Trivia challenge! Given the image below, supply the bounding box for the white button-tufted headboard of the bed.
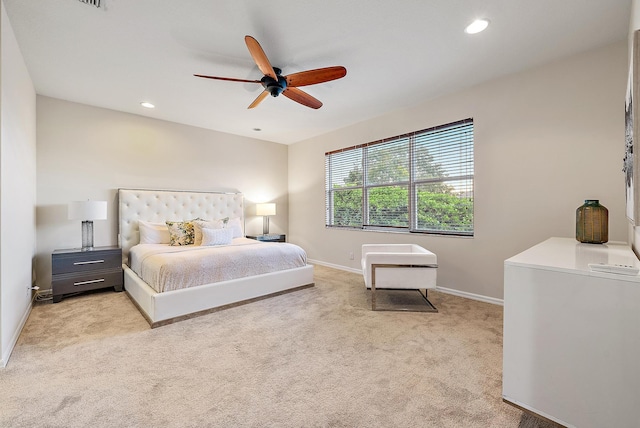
[118,189,244,262]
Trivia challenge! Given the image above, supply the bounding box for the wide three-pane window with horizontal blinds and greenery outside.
[325,119,474,236]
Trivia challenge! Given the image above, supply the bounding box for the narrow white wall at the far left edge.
[0,3,36,367]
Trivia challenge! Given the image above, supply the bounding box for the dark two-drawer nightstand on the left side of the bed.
[51,246,124,303]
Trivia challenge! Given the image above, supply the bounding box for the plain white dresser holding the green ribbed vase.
[502,238,640,428]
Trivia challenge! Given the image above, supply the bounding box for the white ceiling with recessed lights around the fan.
[2,0,631,144]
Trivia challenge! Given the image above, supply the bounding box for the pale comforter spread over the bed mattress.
[129,238,307,293]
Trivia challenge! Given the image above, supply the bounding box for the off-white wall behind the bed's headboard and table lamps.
[36,96,288,288]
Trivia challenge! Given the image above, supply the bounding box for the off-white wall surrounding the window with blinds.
[289,42,627,299]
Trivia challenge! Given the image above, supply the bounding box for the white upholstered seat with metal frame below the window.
[362,244,438,312]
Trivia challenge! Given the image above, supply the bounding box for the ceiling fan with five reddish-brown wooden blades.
[194,36,347,109]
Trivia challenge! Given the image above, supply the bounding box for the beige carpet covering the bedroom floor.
[0,266,549,428]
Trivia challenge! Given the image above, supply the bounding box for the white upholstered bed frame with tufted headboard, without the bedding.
[118,189,314,328]
